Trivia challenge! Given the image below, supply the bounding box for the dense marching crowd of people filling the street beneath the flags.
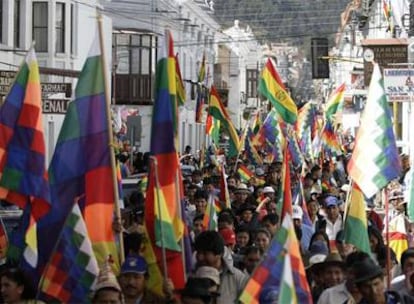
[0,146,414,304]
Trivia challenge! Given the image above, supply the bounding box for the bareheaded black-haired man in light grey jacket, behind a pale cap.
[194,231,248,304]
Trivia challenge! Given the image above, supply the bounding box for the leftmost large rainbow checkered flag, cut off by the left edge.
[0,48,51,267]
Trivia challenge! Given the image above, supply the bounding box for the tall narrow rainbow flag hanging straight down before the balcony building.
[145,30,186,289]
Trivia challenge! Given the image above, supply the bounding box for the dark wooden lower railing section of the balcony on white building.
[112,74,154,105]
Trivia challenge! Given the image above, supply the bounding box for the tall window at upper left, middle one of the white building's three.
[33,2,48,52]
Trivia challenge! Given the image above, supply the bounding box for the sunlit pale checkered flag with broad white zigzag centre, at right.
[348,64,401,198]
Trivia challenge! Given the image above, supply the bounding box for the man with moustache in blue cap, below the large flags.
[119,255,165,304]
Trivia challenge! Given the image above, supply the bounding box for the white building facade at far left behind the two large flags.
[0,0,112,164]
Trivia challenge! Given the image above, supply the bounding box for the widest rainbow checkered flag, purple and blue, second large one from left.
[32,25,119,290]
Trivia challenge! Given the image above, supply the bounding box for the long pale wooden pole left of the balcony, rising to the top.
[98,13,125,264]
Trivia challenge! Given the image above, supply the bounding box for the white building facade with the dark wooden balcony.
[105,0,219,152]
